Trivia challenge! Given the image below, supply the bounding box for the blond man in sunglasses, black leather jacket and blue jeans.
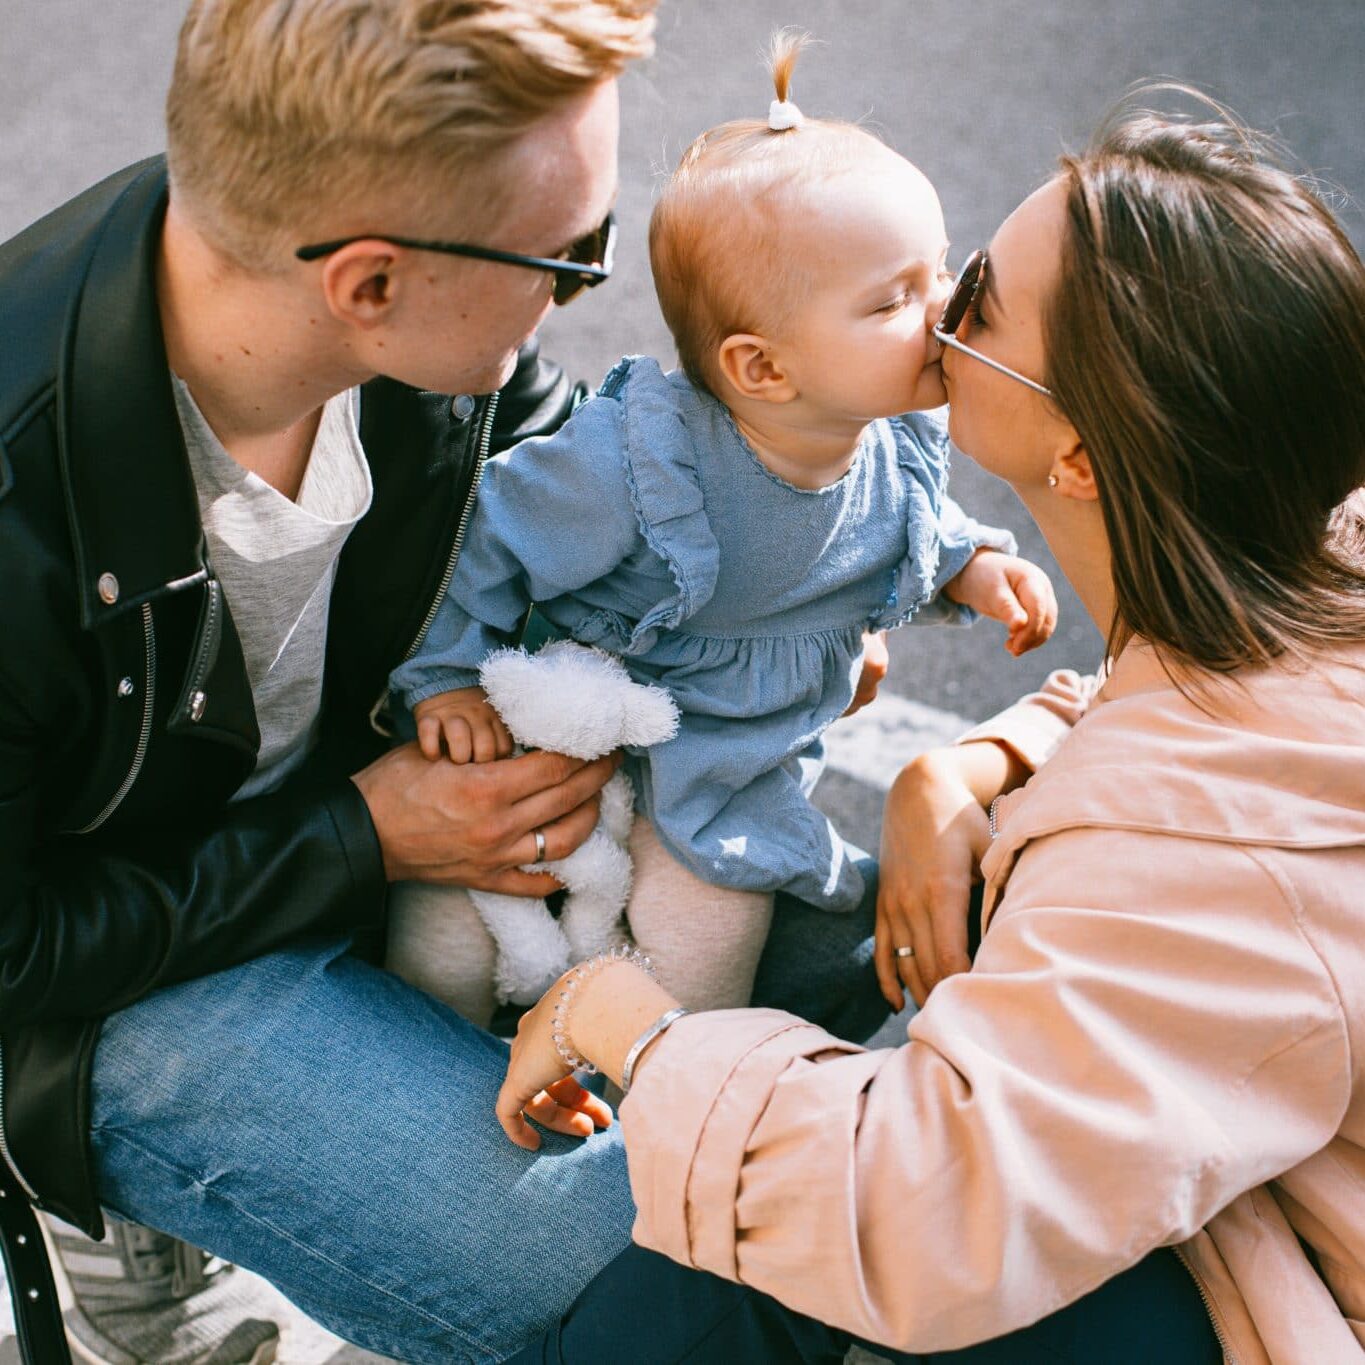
[0,0,652,1365]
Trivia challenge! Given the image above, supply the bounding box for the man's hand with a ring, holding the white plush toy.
[351,744,621,895]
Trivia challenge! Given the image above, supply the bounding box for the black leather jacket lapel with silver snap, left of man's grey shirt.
[57,157,259,753]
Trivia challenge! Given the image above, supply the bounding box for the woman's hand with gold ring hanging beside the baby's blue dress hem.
[874,745,1005,1010]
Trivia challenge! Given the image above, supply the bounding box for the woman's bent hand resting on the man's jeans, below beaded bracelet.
[497,973,612,1152]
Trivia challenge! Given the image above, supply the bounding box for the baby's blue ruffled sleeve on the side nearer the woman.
[871,410,1018,631]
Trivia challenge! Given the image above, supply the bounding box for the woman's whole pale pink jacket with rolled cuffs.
[621,644,1365,1365]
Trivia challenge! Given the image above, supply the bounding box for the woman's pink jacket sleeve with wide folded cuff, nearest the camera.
[621,829,1350,1351]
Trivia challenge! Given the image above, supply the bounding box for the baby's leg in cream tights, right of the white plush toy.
[625,816,773,1010]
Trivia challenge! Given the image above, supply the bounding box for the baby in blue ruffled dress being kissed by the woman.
[390,29,1055,1009]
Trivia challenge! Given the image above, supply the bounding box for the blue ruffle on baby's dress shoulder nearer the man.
[614,356,721,654]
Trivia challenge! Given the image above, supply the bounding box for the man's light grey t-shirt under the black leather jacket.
[171,375,374,800]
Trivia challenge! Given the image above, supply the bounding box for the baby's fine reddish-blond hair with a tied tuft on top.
[650,30,885,392]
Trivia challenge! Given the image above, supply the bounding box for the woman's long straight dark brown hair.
[1044,90,1365,673]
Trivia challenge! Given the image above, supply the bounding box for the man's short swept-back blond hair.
[167,0,657,270]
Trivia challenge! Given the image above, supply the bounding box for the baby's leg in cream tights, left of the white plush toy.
[384,882,498,1028]
